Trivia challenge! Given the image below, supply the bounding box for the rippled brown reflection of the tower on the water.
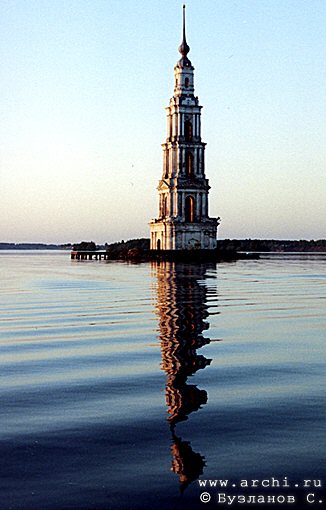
[155,262,215,491]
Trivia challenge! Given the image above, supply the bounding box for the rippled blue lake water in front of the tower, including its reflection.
[0,252,326,510]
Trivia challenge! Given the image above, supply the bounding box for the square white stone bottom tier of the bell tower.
[150,218,218,251]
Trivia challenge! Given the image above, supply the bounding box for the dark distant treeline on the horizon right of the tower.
[217,239,326,252]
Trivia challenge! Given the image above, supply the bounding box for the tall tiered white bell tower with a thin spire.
[150,6,219,250]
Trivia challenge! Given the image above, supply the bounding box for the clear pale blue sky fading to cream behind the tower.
[0,0,326,243]
